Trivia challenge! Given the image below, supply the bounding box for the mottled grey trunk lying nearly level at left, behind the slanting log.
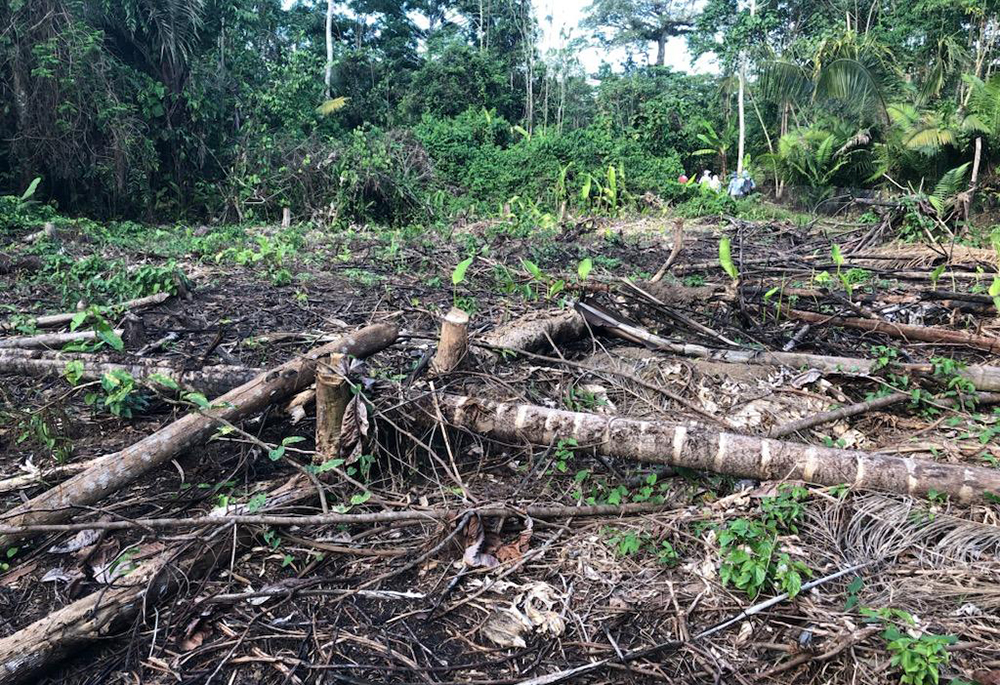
[0,349,262,396]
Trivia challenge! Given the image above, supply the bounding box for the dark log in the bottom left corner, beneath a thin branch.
[0,476,316,685]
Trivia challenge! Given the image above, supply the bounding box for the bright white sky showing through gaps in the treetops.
[283,0,718,75]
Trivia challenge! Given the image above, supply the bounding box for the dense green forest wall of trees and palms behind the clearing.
[0,0,1000,224]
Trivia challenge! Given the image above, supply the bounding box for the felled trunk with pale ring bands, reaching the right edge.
[429,395,1000,502]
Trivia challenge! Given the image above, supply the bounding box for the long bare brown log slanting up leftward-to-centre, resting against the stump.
[0,324,398,548]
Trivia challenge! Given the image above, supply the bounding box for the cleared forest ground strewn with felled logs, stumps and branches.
[0,211,1000,684]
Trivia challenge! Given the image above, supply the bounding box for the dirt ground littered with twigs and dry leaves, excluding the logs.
[0,218,1000,685]
